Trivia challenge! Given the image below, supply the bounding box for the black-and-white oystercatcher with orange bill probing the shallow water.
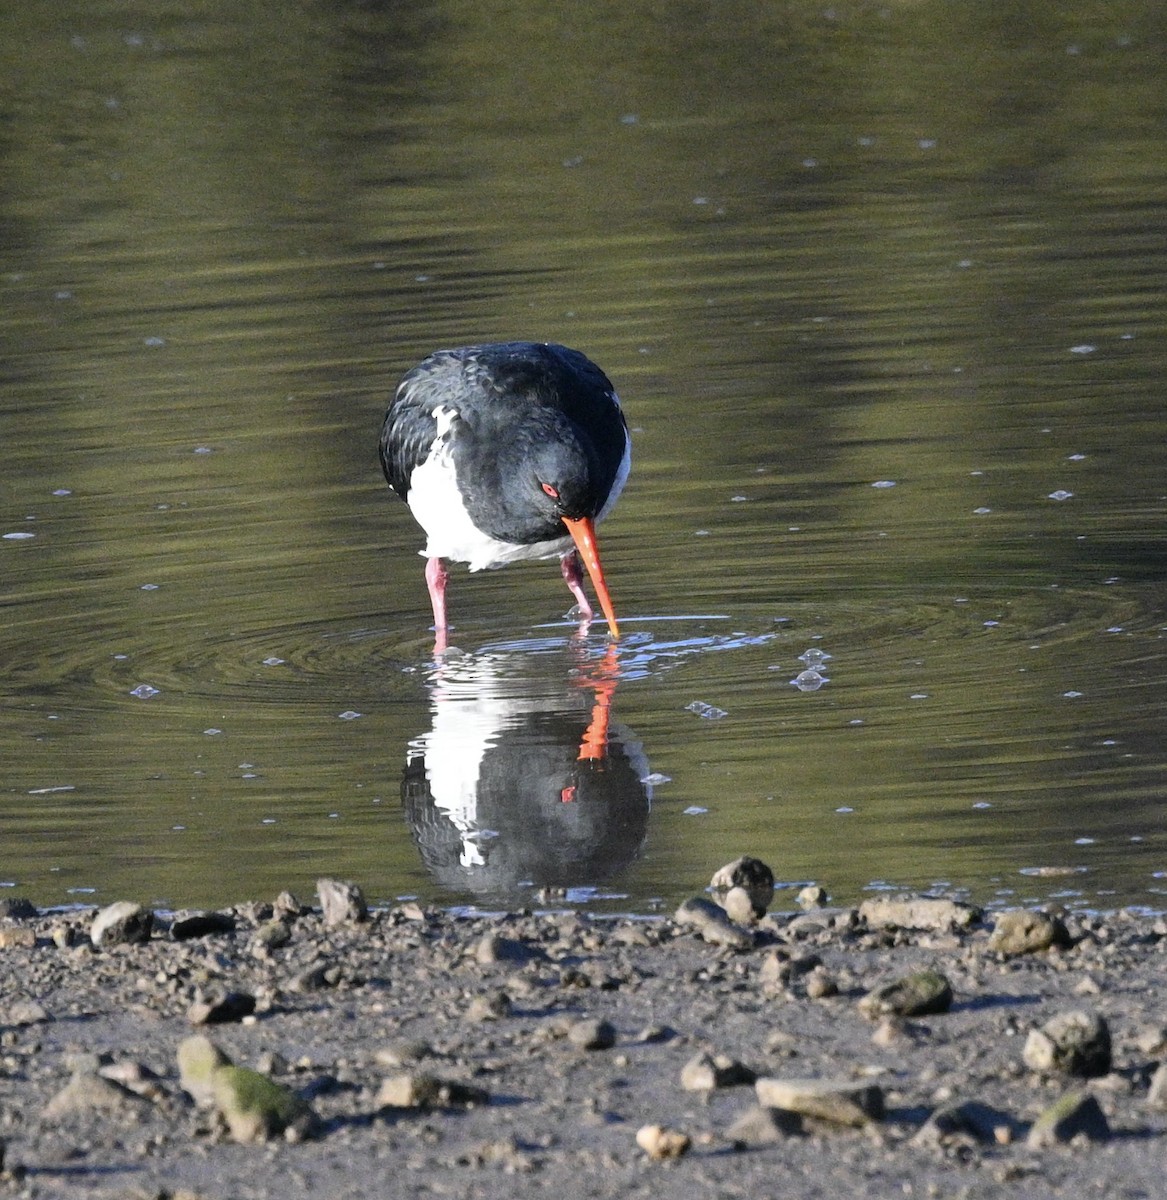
[381,342,632,649]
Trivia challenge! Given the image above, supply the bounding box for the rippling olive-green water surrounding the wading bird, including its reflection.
[0,0,1167,911]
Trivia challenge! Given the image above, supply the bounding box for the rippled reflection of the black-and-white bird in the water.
[401,640,652,901]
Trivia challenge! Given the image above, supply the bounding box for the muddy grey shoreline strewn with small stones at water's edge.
[0,886,1167,1200]
